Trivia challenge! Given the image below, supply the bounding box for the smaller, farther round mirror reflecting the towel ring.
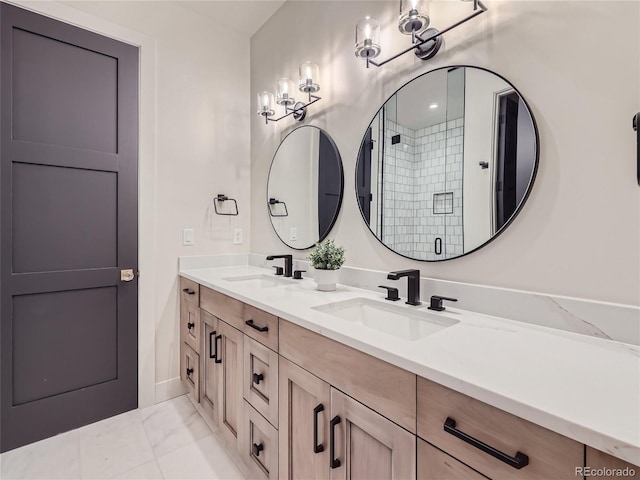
[267,125,344,250]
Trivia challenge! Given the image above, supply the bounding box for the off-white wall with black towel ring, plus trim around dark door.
[16,1,250,405]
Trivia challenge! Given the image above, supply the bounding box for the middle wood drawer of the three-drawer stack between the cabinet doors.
[242,335,278,427]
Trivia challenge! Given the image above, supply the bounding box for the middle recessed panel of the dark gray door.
[12,162,118,274]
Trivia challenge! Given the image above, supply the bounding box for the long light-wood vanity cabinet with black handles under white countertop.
[180,278,640,480]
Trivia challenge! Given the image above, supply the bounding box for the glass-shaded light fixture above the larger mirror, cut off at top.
[355,0,488,68]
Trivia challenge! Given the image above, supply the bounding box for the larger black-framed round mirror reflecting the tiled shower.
[356,66,538,261]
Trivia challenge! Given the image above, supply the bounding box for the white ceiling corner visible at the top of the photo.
[174,0,286,36]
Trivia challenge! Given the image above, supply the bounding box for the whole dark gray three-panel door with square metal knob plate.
[0,3,138,451]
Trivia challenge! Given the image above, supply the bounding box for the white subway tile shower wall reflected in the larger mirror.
[378,118,464,260]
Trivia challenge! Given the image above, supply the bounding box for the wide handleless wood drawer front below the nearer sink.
[280,319,416,433]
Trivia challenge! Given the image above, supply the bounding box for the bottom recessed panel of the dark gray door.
[12,287,118,406]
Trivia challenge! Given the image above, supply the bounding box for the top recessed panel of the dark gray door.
[12,28,118,153]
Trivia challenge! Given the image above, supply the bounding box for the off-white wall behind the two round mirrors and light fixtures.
[251,0,640,305]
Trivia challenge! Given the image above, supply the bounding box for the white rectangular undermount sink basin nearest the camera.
[313,298,458,341]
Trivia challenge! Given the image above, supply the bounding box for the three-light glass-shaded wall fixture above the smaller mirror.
[258,62,321,123]
